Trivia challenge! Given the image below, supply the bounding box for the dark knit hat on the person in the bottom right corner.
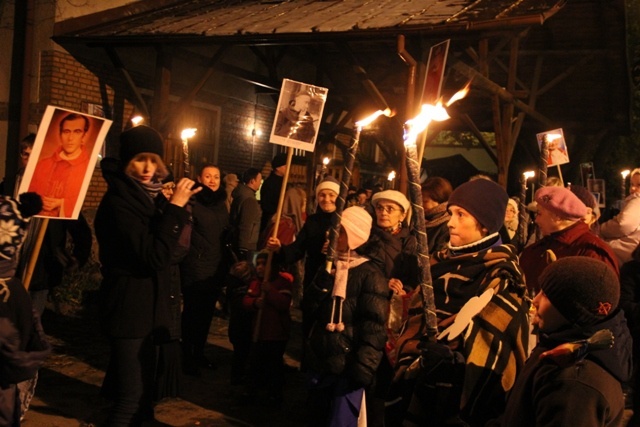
[540,256,620,326]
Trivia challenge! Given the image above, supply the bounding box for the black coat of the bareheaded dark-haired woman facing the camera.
[180,186,229,288]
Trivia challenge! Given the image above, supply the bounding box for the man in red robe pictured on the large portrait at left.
[29,113,90,217]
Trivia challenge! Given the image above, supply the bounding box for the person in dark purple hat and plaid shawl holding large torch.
[390,179,529,425]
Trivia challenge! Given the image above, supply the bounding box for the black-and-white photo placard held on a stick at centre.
[269,79,329,151]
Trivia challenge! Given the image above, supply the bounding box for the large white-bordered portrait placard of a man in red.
[18,105,112,219]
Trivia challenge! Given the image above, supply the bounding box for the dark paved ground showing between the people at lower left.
[23,310,305,427]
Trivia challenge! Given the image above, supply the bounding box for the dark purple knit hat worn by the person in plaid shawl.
[447,179,509,234]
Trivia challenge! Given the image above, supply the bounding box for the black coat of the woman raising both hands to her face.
[94,161,189,342]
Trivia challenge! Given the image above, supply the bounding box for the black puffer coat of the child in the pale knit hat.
[305,261,389,389]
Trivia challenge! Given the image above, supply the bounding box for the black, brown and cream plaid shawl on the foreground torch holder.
[395,245,530,420]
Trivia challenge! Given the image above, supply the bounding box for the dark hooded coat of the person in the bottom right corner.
[502,310,631,427]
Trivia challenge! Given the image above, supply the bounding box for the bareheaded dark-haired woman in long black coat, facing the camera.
[180,164,229,375]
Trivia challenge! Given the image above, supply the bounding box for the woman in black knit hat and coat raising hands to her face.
[95,126,200,426]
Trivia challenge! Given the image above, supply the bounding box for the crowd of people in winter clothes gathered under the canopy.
[0,126,640,426]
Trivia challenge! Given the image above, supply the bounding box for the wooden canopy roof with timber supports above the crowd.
[54,0,630,183]
